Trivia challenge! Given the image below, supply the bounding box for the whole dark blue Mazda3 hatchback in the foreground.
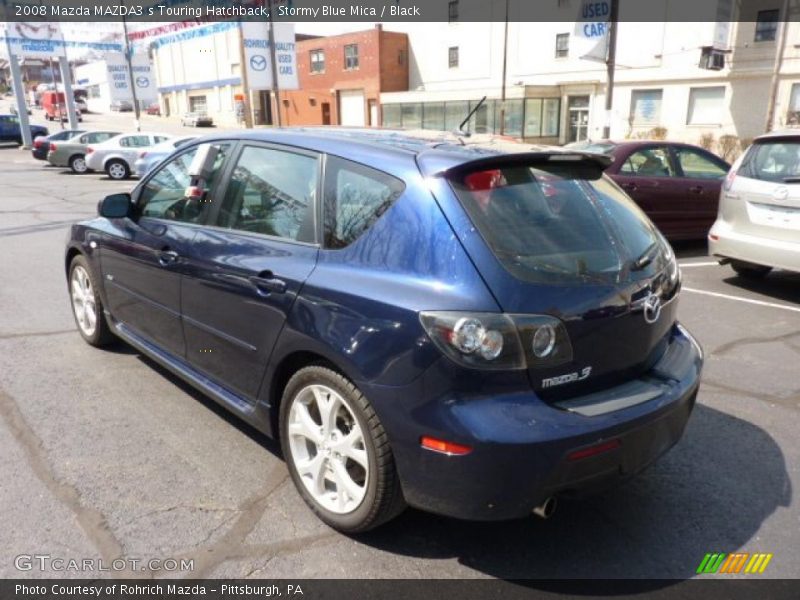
[65,129,703,532]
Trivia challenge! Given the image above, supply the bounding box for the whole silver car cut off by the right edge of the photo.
[708,130,800,278]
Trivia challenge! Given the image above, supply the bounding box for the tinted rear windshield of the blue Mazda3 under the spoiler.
[451,163,663,283]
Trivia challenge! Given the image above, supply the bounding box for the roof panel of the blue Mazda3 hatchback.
[189,126,612,174]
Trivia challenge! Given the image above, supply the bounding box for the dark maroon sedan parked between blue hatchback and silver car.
[567,140,730,240]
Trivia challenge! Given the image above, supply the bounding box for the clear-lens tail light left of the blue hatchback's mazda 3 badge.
[420,311,572,370]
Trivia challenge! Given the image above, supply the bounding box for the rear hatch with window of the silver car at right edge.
[725,136,800,242]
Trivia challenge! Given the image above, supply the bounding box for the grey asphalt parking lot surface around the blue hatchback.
[0,115,800,579]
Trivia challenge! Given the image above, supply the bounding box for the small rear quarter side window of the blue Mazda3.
[324,156,405,249]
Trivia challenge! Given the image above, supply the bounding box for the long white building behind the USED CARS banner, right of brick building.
[381,0,800,150]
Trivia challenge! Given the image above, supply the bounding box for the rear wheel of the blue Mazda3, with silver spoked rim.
[279,366,406,533]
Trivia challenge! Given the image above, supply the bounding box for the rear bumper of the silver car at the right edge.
[708,220,800,271]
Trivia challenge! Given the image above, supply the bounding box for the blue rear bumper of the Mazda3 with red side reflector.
[364,326,703,520]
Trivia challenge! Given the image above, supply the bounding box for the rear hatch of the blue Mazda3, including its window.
[422,153,679,401]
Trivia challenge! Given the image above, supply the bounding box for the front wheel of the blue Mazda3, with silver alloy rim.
[68,254,116,348]
